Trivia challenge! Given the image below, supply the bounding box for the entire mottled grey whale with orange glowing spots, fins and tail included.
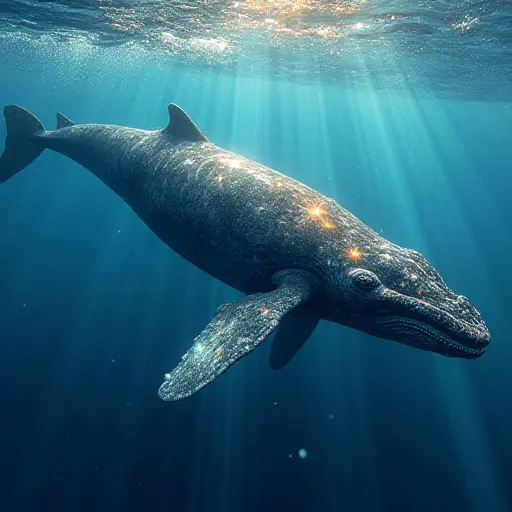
[0,105,490,401]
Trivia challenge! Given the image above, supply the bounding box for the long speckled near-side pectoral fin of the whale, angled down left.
[158,270,315,402]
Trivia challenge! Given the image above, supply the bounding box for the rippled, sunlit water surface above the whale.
[0,0,512,99]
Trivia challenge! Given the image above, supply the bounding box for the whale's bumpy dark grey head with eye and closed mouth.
[338,244,491,359]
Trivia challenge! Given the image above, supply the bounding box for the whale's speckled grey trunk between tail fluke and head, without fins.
[44,117,364,300]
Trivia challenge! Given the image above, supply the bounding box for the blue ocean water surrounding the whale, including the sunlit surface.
[0,0,512,512]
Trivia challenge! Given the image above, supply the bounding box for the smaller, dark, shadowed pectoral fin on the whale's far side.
[269,305,319,370]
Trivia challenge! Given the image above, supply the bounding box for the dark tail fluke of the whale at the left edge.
[0,105,44,183]
